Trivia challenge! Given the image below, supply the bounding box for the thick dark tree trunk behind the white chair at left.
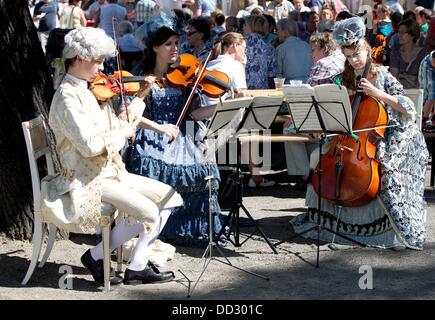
[0,0,53,239]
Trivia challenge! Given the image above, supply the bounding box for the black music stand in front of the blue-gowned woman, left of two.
[208,96,282,254]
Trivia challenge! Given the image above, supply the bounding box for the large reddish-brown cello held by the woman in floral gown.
[312,58,388,207]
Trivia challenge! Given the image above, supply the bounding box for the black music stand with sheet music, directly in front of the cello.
[274,84,366,268]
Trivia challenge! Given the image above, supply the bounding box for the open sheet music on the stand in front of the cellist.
[283,84,352,132]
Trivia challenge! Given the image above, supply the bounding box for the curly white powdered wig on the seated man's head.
[62,27,116,61]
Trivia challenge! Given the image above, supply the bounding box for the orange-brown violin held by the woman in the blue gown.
[166,53,230,98]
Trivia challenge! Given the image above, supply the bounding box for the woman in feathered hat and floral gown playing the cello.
[292,17,428,249]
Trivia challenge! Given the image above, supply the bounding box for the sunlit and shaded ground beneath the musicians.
[0,169,435,300]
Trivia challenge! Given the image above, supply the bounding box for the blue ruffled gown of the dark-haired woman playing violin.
[126,87,221,246]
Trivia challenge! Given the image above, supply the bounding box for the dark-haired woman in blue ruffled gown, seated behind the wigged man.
[126,26,221,246]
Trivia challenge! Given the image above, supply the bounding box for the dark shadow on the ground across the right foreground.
[119,243,435,300]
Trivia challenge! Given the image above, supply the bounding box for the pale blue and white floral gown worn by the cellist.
[291,67,429,249]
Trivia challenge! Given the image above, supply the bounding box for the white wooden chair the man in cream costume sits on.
[22,115,122,291]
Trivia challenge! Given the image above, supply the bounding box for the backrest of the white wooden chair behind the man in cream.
[21,115,55,211]
